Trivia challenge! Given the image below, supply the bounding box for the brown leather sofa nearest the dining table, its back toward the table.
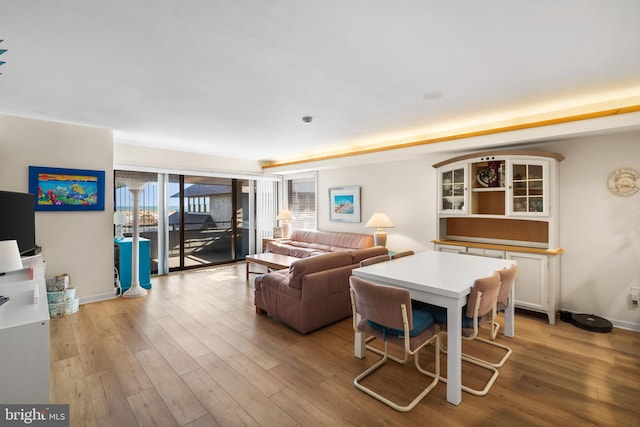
[255,244,388,334]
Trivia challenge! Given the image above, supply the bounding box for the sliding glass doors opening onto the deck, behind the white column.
[114,171,262,274]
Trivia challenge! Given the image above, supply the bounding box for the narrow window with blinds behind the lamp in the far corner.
[283,173,318,230]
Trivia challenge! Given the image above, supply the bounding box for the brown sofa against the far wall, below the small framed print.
[267,230,373,258]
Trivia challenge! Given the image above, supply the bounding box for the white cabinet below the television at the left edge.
[0,257,49,404]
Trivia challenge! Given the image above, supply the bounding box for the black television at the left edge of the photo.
[0,191,36,256]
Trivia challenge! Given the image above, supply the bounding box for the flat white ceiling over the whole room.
[0,0,640,166]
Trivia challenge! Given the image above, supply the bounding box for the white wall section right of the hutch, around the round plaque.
[550,132,640,331]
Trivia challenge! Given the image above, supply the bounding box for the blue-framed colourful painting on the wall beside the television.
[29,166,104,211]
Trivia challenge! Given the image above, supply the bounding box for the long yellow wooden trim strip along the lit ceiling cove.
[262,105,640,170]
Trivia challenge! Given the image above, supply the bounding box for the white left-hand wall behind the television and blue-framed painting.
[0,115,114,302]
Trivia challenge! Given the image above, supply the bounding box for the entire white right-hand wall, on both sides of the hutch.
[318,131,640,331]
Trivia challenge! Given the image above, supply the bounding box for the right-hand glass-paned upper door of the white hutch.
[511,162,547,215]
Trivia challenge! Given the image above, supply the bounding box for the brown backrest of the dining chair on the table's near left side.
[349,276,413,330]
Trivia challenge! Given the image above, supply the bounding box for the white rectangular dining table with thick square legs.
[353,251,515,405]
